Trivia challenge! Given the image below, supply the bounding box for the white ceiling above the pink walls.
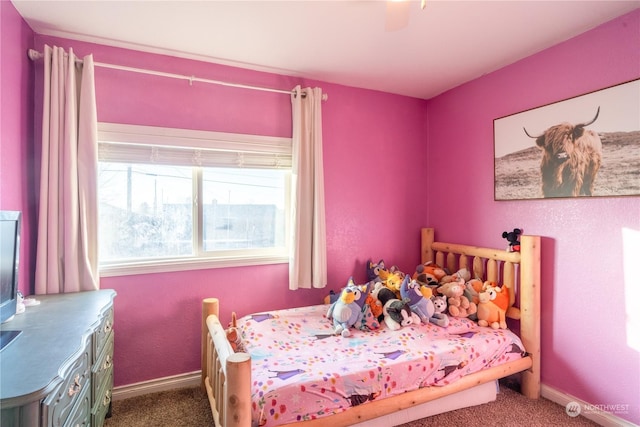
[12,0,640,99]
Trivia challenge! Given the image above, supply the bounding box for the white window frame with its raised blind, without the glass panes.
[97,122,292,277]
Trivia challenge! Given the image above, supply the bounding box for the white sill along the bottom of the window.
[100,255,289,277]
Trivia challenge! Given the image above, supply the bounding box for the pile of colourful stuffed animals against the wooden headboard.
[326,256,520,337]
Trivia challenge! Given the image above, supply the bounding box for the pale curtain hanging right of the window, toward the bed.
[289,86,327,289]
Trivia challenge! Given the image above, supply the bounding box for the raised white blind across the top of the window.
[98,123,291,169]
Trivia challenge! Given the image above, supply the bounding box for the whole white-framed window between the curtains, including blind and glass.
[98,123,291,276]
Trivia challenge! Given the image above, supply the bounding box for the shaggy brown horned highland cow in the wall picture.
[523,107,602,197]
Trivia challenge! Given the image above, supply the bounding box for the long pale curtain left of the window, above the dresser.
[35,46,100,294]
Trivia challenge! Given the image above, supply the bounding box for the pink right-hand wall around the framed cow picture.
[427,10,640,424]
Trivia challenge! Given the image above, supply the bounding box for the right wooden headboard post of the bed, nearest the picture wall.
[520,235,540,399]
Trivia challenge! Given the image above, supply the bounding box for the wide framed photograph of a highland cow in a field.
[493,79,640,200]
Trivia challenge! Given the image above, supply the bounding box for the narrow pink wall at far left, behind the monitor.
[0,1,36,295]
